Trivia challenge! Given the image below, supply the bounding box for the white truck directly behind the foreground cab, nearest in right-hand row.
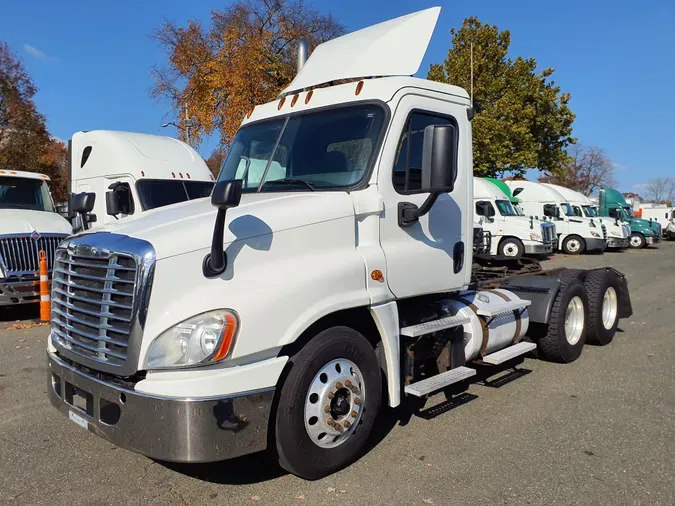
[473,177,557,258]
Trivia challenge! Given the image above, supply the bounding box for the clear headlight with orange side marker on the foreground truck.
[145,309,239,369]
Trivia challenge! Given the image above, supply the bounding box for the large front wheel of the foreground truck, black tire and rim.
[275,327,382,480]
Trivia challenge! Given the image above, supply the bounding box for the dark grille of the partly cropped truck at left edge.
[0,234,67,276]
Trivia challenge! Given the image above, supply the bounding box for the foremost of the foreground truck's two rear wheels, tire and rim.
[537,278,588,363]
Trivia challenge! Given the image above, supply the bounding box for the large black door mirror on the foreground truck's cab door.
[398,124,459,227]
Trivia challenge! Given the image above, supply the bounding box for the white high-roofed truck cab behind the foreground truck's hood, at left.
[69,130,215,230]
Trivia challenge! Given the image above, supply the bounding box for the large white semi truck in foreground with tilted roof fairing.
[48,8,631,479]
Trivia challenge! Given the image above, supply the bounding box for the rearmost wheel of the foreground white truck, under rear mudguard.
[584,270,619,346]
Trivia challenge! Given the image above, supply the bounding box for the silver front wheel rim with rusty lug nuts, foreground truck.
[304,358,366,448]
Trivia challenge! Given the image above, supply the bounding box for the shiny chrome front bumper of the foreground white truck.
[47,353,274,462]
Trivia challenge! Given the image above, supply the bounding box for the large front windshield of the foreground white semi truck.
[220,104,384,192]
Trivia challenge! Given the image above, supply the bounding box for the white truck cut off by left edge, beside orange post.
[0,170,73,306]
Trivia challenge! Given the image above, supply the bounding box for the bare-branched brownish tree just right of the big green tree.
[539,144,616,195]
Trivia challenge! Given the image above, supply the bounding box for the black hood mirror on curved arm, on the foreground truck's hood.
[202,179,243,278]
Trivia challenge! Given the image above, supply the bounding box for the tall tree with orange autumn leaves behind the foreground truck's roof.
[151,0,344,150]
